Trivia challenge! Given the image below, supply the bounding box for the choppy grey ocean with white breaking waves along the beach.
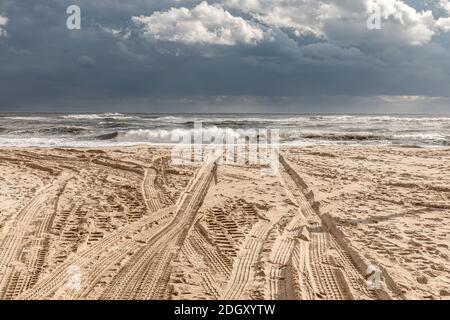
[0,113,450,147]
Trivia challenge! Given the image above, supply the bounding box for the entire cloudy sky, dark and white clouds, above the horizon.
[0,0,450,113]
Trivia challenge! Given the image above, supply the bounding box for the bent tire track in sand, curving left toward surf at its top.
[18,161,181,299]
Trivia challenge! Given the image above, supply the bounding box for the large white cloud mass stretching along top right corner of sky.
[224,0,450,47]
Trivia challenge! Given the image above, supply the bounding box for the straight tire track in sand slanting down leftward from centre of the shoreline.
[102,158,220,299]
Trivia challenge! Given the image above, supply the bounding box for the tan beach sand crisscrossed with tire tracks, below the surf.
[0,146,450,299]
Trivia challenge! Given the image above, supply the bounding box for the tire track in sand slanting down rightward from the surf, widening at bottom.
[280,155,389,300]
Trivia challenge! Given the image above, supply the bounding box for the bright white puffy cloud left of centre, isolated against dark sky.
[132,2,264,45]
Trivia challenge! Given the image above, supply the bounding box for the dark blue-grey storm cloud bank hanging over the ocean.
[0,0,450,112]
